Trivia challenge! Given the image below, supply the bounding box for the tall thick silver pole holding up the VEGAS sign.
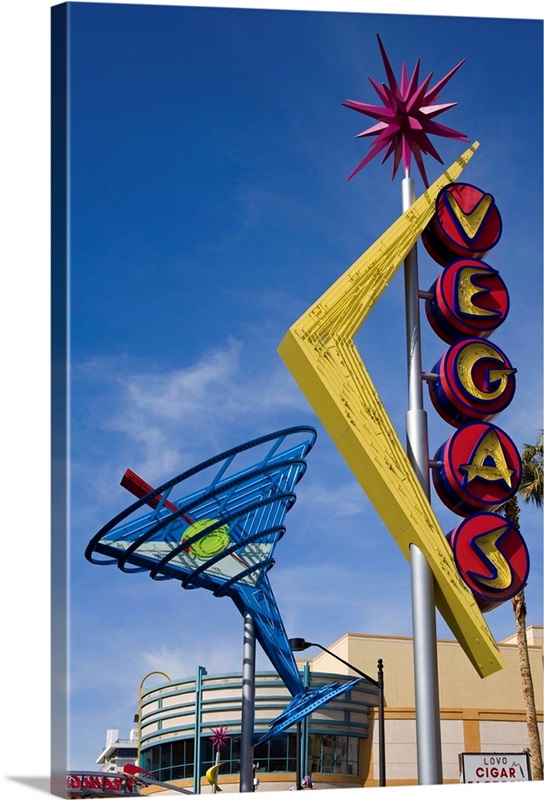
[402,174,442,785]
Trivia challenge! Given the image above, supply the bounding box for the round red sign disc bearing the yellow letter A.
[433,422,521,517]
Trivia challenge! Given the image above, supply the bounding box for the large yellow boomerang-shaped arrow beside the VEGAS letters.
[279,142,504,677]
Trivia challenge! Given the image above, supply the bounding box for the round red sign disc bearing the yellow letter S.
[447,512,529,611]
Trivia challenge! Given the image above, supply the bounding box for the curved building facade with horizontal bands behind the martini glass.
[140,664,378,792]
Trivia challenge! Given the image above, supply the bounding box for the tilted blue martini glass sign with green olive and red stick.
[85,426,360,742]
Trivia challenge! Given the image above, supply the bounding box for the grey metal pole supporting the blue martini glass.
[240,612,255,792]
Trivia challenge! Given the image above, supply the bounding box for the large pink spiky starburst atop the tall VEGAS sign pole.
[342,36,468,188]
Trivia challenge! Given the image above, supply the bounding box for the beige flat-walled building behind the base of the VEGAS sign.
[311,626,543,786]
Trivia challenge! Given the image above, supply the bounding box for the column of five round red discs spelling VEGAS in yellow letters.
[428,183,529,612]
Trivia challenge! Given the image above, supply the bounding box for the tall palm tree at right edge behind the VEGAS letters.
[501,431,544,781]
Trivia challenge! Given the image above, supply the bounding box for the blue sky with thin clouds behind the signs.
[1,3,542,796]
